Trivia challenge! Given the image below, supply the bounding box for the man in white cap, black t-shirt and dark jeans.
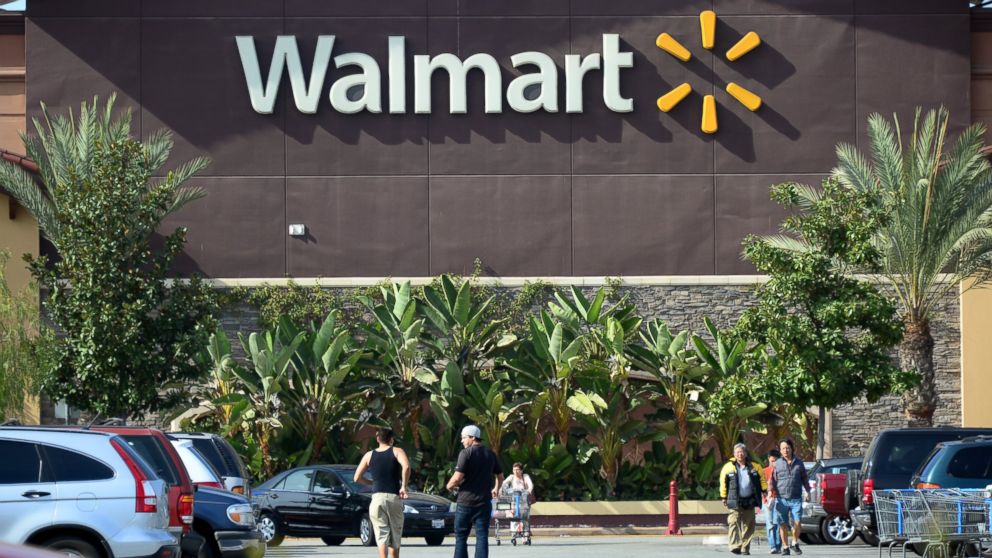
[448,425,503,558]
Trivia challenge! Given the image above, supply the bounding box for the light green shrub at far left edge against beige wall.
[0,251,55,418]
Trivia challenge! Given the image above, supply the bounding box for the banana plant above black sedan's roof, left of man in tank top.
[279,313,376,464]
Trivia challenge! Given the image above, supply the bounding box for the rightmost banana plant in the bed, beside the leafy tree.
[692,318,768,460]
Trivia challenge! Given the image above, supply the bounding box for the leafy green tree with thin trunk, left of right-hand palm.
[732,179,911,455]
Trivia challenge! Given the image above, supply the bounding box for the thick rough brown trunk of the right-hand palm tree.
[899,317,937,426]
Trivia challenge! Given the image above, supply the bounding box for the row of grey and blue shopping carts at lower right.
[874,488,992,558]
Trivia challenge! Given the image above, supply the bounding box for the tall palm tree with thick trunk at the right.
[828,108,992,424]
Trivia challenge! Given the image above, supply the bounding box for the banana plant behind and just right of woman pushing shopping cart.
[503,310,586,445]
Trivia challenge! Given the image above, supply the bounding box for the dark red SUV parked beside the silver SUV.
[91,425,204,557]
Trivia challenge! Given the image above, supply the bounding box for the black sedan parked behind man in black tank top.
[252,465,455,546]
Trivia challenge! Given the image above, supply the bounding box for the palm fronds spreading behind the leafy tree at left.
[0,95,210,248]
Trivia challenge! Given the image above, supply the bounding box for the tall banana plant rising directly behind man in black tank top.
[358,281,439,448]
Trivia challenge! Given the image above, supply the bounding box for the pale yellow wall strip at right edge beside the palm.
[961,280,992,427]
